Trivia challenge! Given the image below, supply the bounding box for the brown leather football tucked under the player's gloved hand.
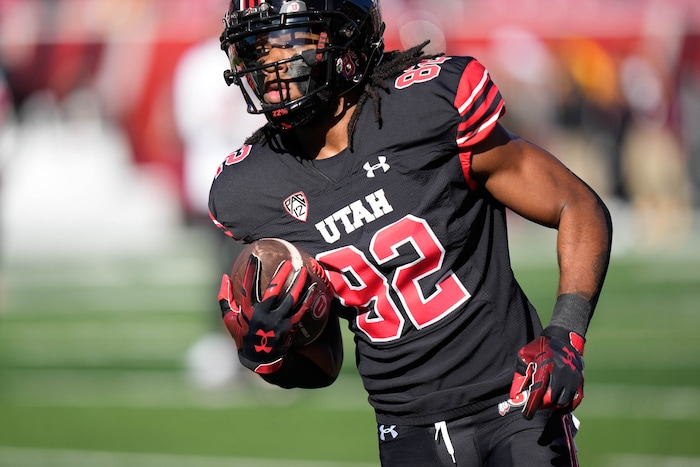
[231,238,333,347]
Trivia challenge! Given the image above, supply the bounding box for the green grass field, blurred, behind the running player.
[0,225,700,467]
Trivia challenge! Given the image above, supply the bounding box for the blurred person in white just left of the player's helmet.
[173,35,265,387]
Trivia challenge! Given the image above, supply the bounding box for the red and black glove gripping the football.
[219,255,310,374]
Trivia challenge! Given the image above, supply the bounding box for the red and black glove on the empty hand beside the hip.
[510,326,585,420]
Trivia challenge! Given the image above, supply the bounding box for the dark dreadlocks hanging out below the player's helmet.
[245,41,443,151]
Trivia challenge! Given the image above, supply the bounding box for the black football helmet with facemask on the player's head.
[220,0,384,129]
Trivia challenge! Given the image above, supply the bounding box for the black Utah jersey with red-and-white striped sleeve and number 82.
[210,57,541,424]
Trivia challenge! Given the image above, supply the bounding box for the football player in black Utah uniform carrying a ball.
[209,0,611,467]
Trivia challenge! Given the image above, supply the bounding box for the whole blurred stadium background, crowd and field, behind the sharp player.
[0,0,700,467]
